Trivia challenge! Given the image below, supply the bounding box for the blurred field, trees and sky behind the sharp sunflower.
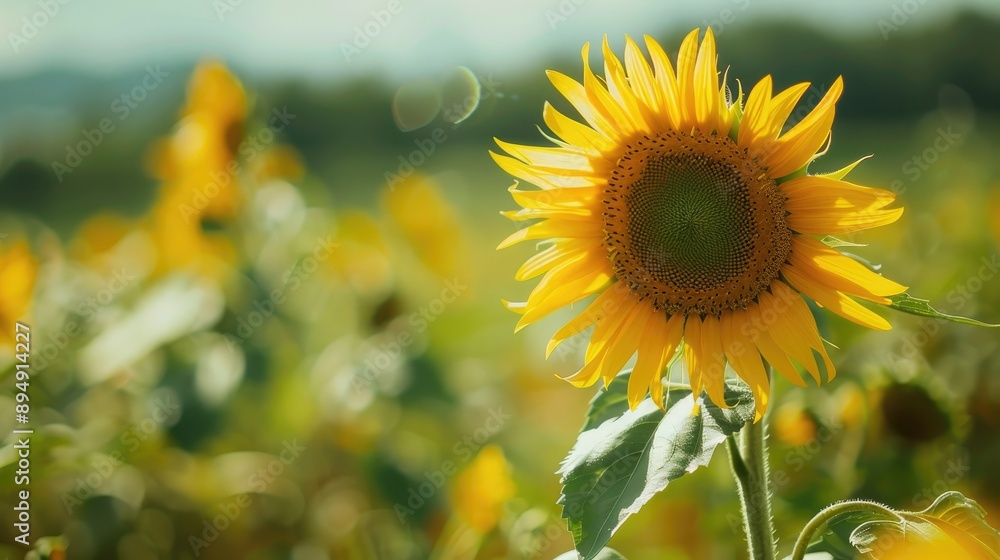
[0,0,1000,560]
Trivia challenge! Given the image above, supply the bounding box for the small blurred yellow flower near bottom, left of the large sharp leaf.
[451,445,515,534]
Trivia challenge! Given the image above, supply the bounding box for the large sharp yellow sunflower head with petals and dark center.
[491,29,906,419]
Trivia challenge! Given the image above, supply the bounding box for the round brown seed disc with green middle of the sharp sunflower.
[604,131,791,316]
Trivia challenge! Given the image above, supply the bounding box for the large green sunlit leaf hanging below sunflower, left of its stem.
[559,384,754,560]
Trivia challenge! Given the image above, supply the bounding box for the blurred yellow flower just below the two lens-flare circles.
[382,174,467,279]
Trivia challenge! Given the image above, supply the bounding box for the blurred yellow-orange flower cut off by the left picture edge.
[0,240,38,348]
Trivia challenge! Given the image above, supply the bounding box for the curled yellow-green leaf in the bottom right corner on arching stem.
[851,492,1000,560]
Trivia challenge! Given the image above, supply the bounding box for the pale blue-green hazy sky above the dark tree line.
[0,0,1000,81]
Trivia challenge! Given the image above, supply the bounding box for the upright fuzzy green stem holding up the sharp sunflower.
[728,416,777,560]
